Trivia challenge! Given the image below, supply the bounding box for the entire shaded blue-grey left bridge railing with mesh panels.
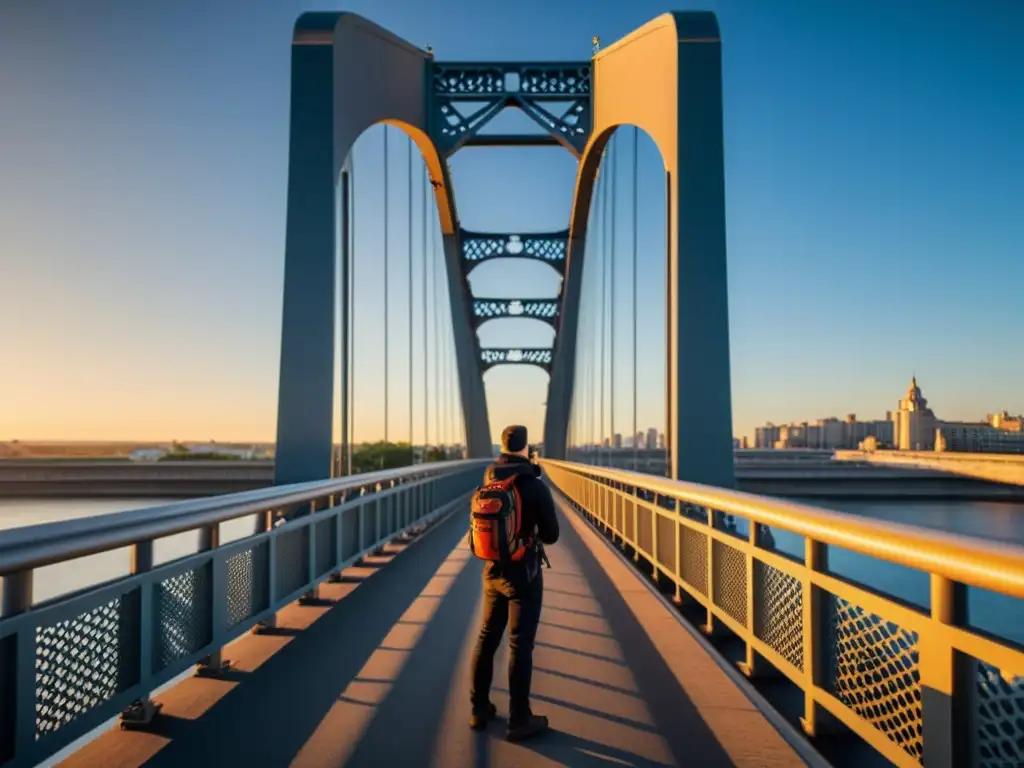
[0,461,482,768]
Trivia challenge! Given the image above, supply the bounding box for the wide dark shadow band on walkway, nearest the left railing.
[140,511,473,768]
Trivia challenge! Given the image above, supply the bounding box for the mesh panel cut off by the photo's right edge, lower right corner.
[975,662,1024,768]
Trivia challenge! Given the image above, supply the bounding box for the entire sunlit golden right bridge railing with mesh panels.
[544,461,1024,768]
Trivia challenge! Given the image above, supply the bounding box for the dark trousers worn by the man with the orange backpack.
[470,563,544,725]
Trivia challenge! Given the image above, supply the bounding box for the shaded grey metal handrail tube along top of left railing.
[0,459,484,575]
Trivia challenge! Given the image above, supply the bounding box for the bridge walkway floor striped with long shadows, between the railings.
[63,495,804,768]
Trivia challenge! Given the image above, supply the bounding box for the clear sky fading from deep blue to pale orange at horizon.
[0,0,1024,440]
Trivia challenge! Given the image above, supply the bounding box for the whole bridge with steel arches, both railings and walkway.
[0,12,1024,768]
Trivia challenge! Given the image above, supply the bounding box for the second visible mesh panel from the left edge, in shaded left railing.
[153,562,213,672]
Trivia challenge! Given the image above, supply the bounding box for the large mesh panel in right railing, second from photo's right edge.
[824,595,924,761]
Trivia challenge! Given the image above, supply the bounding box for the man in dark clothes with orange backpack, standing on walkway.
[469,426,558,741]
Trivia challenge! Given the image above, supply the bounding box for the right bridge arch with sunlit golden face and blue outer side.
[545,11,735,487]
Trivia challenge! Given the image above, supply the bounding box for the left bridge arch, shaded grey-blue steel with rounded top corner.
[274,12,490,484]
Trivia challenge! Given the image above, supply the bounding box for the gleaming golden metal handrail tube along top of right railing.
[544,459,1024,598]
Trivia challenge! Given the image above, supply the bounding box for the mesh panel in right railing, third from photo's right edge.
[754,560,804,670]
